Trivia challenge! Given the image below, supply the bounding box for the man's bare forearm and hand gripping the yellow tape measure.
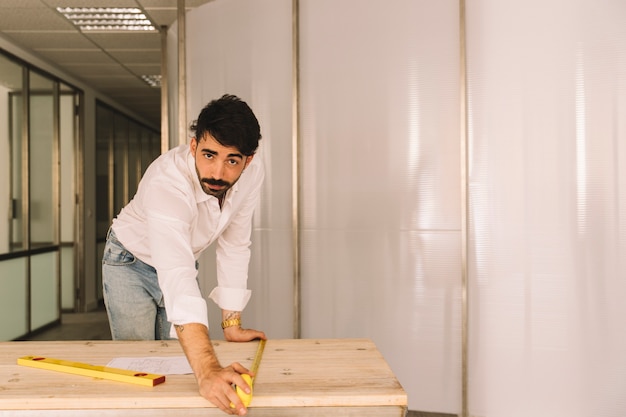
[174,323,251,416]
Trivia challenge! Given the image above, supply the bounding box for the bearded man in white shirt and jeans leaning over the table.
[102,95,265,415]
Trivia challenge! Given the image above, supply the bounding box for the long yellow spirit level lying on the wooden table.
[17,356,165,387]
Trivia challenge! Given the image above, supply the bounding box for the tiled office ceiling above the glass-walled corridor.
[0,0,211,127]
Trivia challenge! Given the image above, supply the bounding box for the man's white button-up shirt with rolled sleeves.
[112,141,264,337]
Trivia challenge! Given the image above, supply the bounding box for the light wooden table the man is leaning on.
[0,339,407,417]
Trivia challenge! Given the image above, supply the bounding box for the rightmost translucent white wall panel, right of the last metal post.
[467,0,626,417]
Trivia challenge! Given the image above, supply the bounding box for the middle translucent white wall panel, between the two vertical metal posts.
[300,0,461,413]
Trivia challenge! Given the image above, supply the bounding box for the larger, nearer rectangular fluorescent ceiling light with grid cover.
[57,7,156,32]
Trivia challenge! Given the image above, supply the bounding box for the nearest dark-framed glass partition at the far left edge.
[0,51,80,340]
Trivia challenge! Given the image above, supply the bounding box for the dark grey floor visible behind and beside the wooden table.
[24,308,456,417]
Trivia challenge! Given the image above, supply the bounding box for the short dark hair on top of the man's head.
[191,94,261,156]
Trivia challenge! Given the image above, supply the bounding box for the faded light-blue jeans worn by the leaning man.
[102,229,171,340]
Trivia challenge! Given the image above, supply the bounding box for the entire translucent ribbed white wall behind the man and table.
[176,0,626,417]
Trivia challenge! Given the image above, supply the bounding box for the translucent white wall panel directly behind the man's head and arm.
[184,0,293,338]
